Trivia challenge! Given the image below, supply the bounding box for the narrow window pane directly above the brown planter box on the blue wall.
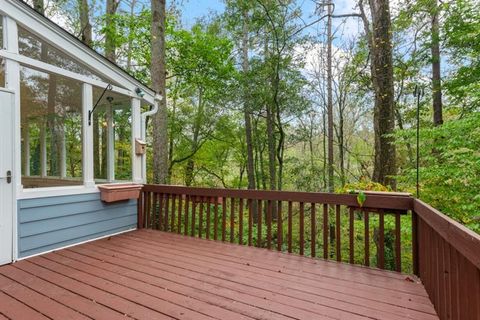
[92,87,132,184]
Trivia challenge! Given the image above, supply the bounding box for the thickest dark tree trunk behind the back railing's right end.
[359,0,397,188]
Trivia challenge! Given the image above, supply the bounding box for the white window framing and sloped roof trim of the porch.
[0,13,154,199]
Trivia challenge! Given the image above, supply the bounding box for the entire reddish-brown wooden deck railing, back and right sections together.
[138,185,480,320]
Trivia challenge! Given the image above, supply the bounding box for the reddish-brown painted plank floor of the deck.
[0,230,438,320]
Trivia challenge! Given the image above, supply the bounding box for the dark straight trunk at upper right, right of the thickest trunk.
[431,0,443,126]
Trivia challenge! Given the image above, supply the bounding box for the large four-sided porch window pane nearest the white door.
[20,67,83,188]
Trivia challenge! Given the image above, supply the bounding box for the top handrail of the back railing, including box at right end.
[143,184,414,211]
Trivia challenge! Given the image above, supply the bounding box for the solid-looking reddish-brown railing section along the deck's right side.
[413,199,480,320]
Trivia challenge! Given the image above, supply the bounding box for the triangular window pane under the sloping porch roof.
[18,26,116,82]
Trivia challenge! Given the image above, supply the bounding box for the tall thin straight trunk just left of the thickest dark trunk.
[327,5,335,192]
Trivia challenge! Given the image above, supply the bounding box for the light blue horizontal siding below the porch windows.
[18,193,137,257]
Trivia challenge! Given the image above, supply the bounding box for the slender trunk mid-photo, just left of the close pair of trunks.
[242,10,256,190]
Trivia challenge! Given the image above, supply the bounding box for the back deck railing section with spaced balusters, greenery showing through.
[139,185,413,271]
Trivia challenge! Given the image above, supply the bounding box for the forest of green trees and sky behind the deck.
[31,0,480,236]
